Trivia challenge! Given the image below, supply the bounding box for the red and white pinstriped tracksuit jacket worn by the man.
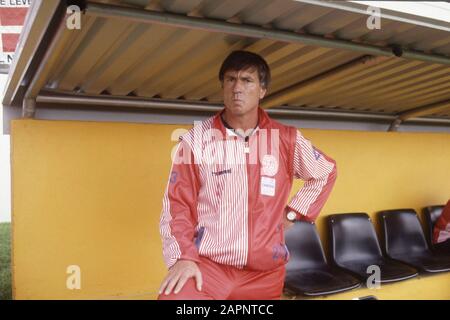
[160,108,336,271]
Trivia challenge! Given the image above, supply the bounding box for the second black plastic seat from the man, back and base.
[328,213,418,283]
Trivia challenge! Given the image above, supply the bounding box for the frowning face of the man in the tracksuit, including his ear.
[223,68,266,116]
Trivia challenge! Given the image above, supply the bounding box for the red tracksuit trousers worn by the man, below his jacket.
[158,257,285,300]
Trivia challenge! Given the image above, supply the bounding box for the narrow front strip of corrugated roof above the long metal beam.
[91,0,450,55]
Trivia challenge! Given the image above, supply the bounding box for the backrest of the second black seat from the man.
[328,213,382,266]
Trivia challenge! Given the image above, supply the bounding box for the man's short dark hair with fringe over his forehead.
[219,50,270,89]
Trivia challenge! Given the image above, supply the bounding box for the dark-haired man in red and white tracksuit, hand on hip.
[159,51,336,299]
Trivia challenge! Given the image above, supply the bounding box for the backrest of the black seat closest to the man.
[285,221,327,271]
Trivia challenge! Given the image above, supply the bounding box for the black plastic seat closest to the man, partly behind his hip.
[284,221,360,296]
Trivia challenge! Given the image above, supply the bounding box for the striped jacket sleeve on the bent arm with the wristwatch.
[288,130,337,221]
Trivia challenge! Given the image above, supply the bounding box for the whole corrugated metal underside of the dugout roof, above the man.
[3,0,450,124]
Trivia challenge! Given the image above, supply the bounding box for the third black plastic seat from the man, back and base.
[379,209,450,272]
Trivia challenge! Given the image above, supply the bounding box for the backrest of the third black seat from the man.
[379,209,429,257]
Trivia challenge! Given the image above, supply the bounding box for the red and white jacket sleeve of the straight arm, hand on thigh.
[160,141,200,268]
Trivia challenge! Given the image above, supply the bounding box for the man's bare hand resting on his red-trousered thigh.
[159,260,203,295]
